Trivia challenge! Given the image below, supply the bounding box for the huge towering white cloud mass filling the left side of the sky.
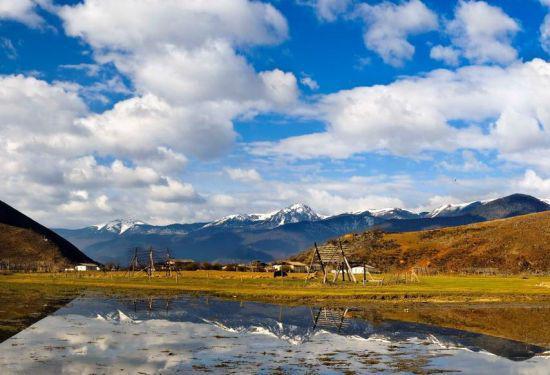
[0,0,299,225]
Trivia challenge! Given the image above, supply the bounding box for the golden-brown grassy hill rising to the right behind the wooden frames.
[294,212,550,273]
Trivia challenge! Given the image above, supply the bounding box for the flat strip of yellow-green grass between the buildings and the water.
[0,271,550,306]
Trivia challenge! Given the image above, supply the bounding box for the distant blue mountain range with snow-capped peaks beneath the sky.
[55,194,550,265]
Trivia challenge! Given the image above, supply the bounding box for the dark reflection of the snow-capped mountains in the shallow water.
[61,297,545,361]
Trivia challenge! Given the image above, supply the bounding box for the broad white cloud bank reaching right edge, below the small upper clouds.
[253,59,550,168]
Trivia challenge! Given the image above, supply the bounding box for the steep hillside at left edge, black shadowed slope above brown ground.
[0,201,93,271]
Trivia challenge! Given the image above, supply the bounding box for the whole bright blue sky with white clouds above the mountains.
[0,0,550,228]
